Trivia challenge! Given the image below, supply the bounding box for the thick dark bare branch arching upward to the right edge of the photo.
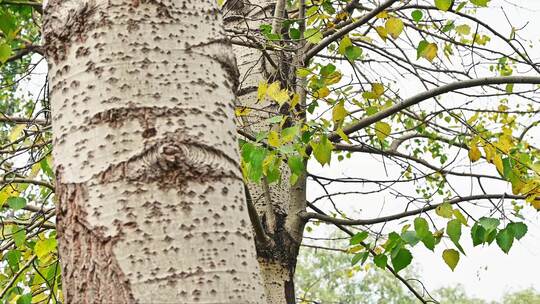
[330,76,540,142]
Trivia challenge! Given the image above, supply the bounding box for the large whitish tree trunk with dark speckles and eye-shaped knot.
[44,0,266,304]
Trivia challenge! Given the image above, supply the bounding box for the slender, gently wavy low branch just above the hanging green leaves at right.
[300,193,525,226]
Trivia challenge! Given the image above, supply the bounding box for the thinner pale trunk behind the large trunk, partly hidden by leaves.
[224,0,306,304]
